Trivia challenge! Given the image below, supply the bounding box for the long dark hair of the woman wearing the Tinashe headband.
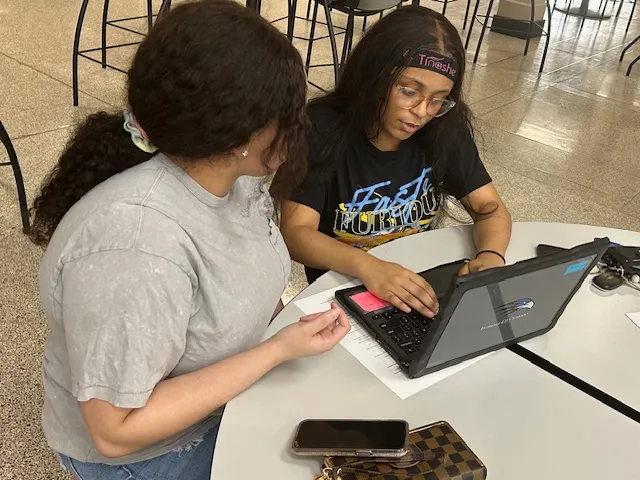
[310,6,473,204]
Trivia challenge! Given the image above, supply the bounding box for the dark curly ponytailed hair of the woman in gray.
[29,0,307,245]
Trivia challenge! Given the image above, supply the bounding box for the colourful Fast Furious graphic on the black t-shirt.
[333,167,439,250]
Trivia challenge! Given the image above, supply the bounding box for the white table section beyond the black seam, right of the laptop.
[509,223,640,411]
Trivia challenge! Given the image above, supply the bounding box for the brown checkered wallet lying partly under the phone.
[318,422,487,480]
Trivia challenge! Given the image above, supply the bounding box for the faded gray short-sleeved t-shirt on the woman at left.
[40,155,291,464]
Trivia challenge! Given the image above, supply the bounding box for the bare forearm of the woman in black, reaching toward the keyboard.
[285,226,374,278]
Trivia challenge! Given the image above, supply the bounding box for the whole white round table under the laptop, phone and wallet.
[211,223,640,480]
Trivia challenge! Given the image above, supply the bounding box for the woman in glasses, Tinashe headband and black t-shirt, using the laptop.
[282,6,511,317]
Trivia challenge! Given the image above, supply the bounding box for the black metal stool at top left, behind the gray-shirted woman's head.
[71,0,171,107]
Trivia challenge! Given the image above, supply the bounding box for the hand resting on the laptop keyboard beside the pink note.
[360,257,439,318]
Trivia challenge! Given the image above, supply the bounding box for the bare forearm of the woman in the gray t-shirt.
[92,340,284,457]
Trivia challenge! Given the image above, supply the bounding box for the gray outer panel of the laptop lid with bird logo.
[427,255,596,368]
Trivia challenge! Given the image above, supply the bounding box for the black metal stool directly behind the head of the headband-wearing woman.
[305,0,402,90]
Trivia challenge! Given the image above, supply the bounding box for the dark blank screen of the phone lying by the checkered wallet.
[294,420,407,450]
